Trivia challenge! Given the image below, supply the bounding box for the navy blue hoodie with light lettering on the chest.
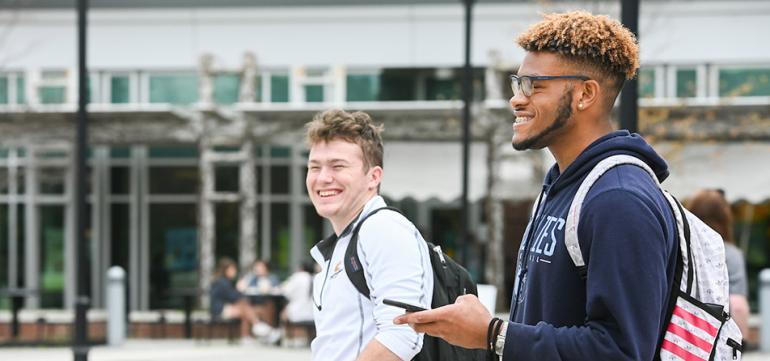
[503,131,677,361]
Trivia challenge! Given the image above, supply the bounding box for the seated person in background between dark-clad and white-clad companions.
[236,260,279,327]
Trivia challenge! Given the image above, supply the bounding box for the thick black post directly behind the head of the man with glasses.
[620,0,639,133]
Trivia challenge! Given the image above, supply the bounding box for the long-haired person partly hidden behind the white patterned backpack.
[687,189,749,340]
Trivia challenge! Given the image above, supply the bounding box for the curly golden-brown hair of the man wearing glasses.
[516,11,639,101]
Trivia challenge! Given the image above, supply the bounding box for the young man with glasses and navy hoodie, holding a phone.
[395,11,678,361]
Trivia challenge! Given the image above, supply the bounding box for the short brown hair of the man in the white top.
[305,109,384,170]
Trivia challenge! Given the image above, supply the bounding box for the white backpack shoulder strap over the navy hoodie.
[564,154,660,280]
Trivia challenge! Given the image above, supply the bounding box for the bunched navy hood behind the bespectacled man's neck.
[544,130,669,195]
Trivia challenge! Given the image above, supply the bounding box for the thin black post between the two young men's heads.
[460,0,473,265]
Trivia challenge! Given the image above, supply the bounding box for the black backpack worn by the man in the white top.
[345,207,488,361]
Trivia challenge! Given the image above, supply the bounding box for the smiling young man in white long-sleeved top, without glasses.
[306,110,433,361]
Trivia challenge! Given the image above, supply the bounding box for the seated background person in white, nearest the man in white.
[280,260,315,346]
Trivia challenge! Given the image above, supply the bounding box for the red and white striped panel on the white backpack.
[660,297,722,361]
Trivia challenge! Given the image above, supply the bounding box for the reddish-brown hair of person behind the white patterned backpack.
[687,189,735,244]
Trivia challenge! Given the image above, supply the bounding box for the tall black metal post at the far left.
[72,0,90,361]
